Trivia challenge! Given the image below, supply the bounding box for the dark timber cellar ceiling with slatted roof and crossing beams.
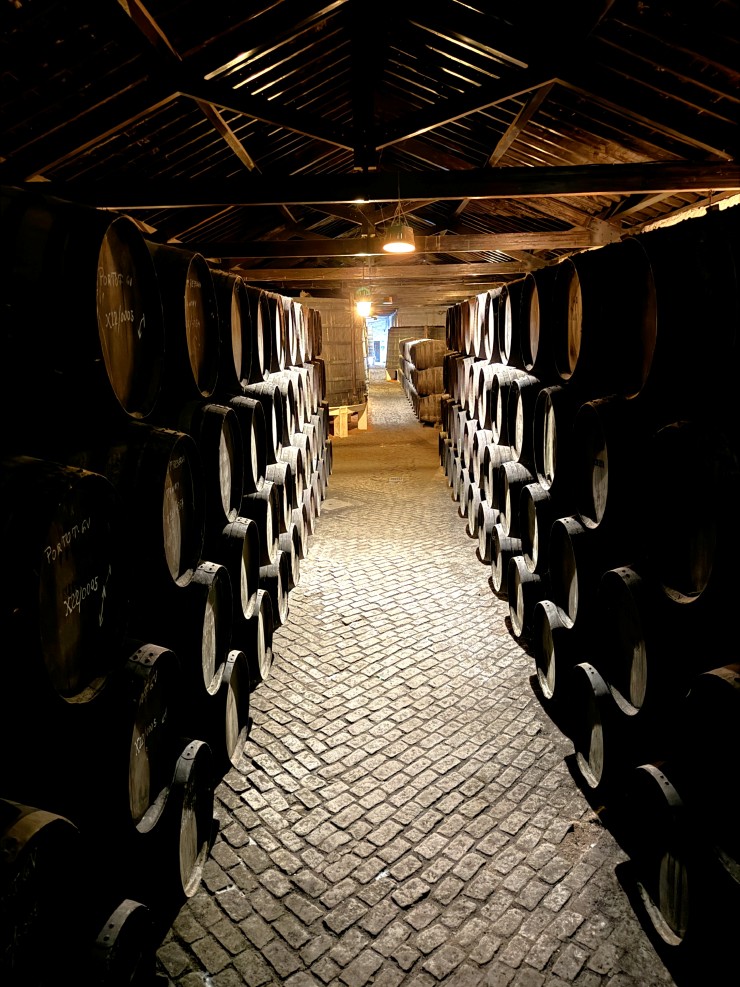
[0,0,740,310]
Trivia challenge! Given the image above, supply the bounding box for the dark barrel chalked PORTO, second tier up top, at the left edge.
[0,456,129,704]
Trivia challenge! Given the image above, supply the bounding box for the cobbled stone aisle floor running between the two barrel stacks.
[158,372,674,987]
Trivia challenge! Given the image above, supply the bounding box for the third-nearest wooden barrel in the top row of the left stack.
[211,266,252,402]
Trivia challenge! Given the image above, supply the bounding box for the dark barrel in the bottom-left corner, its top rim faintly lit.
[0,798,82,987]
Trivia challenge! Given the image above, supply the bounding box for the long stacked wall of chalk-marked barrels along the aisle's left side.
[0,190,331,987]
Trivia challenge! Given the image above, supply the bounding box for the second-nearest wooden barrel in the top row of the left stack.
[147,241,220,414]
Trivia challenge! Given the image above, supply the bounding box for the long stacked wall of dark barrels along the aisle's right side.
[440,210,740,946]
